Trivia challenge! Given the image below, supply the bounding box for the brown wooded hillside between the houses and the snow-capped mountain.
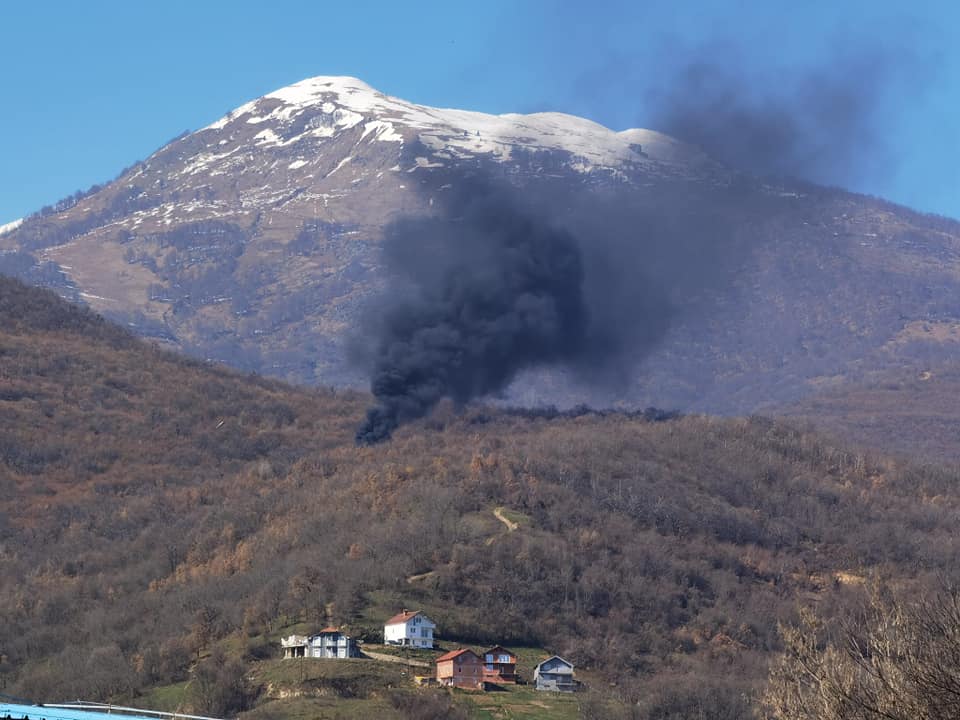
[0,272,960,718]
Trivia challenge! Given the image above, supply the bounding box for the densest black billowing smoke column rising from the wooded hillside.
[356,181,589,444]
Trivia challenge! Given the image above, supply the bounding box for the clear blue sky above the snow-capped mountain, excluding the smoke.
[0,0,960,224]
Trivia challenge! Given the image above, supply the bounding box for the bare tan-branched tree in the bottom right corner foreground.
[763,588,960,720]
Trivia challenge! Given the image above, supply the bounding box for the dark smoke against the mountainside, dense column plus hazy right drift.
[354,172,751,444]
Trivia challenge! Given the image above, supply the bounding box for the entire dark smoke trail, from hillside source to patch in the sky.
[356,44,928,444]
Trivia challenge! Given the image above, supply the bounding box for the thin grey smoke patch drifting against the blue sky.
[642,41,916,187]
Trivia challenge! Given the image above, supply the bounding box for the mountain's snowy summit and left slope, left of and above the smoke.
[0,76,729,394]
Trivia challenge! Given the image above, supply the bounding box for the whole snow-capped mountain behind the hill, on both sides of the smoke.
[0,77,960,413]
